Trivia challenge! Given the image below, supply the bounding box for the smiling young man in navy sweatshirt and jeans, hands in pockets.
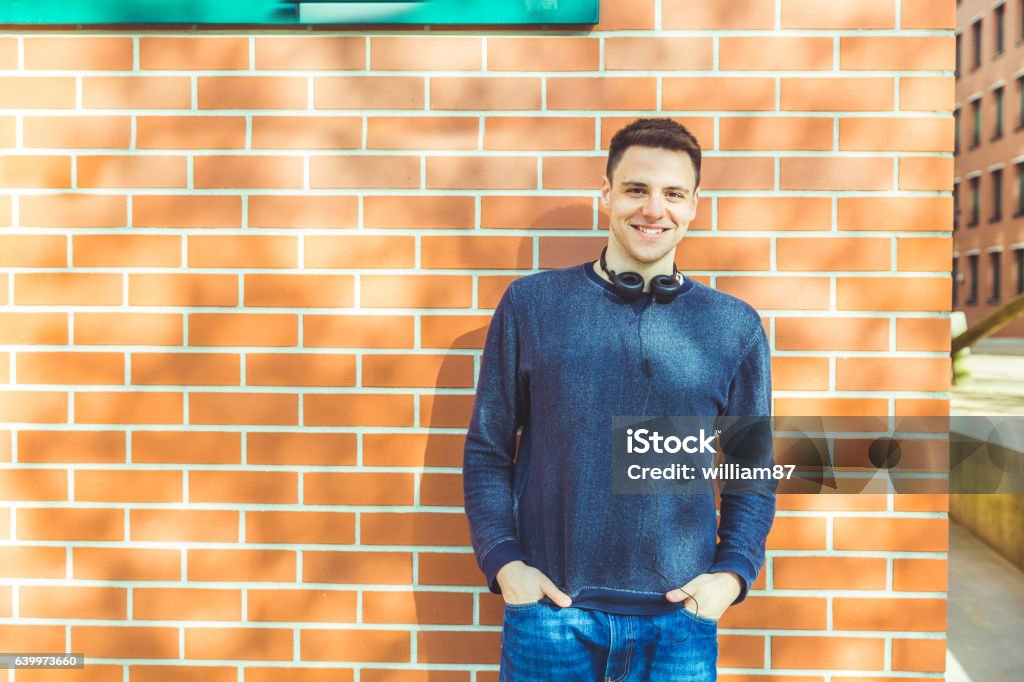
[463,119,775,682]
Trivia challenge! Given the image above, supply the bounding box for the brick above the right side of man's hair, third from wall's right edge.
[662,78,770,112]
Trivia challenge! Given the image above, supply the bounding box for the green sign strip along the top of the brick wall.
[0,0,599,25]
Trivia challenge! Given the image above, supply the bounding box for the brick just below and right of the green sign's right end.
[604,36,714,71]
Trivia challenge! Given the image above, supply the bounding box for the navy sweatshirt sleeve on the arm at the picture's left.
[462,287,528,594]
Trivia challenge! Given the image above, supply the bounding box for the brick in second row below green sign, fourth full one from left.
[428,76,541,111]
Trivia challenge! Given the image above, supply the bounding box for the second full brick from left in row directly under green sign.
[138,36,249,71]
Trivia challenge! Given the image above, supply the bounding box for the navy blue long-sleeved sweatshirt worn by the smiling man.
[463,263,775,614]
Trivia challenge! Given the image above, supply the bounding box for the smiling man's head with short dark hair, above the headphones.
[601,119,700,279]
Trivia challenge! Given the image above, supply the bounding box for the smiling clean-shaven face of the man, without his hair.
[601,146,698,269]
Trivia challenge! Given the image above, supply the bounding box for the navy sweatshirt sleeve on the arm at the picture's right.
[710,319,777,604]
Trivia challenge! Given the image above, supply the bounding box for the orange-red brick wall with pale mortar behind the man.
[0,0,954,682]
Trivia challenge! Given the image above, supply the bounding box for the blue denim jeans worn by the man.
[499,602,718,682]
